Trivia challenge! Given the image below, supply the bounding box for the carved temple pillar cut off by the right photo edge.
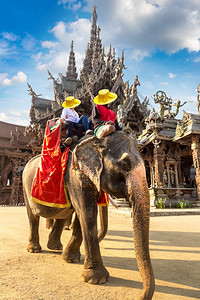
[191,137,200,200]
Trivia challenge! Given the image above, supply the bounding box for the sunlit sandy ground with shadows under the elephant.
[0,207,200,300]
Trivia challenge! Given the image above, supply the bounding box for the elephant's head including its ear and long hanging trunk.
[73,131,154,299]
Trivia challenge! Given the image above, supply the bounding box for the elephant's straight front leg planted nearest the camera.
[78,196,109,284]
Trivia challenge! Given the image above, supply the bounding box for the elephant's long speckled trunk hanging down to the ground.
[127,162,155,299]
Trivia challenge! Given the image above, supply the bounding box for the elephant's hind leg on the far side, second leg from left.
[47,219,65,250]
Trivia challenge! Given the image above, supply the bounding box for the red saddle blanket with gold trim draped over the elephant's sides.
[31,125,109,208]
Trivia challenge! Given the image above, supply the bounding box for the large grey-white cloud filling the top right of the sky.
[82,0,200,53]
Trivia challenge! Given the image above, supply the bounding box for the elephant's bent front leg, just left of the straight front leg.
[62,215,82,263]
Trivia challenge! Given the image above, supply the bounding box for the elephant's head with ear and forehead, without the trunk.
[73,132,145,203]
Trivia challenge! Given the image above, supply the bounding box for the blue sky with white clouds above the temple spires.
[0,0,200,125]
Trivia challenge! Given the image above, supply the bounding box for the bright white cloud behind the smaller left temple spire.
[32,19,91,74]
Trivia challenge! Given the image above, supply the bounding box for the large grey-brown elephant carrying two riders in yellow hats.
[23,131,155,299]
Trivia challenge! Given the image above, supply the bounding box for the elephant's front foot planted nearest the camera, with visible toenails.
[81,265,109,284]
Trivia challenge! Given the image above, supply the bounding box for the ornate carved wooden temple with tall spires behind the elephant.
[0,7,200,206]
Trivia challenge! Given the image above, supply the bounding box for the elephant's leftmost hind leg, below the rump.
[26,203,42,253]
